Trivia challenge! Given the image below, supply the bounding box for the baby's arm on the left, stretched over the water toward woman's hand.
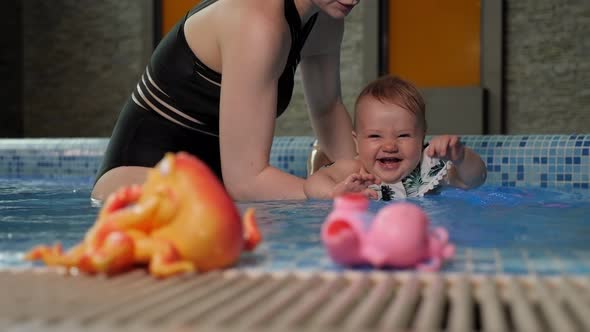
[303,160,377,199]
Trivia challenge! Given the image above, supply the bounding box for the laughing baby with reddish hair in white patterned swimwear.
[304,76,487,200]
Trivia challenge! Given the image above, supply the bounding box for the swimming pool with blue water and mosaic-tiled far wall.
[0,135,590,275]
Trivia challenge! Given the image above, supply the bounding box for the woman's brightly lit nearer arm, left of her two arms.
[219,7,305,200]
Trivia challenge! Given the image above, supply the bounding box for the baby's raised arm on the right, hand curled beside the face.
[426,135,487,189]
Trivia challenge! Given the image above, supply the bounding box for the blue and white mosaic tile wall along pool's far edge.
[0,135,590,189]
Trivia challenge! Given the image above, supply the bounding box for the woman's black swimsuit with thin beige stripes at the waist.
[96,0,317,184]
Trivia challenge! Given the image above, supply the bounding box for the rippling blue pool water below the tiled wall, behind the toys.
[0,179,590,275]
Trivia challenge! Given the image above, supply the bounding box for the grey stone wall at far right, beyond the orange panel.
[504,0,590,134]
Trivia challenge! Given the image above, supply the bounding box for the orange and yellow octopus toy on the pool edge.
[26,152,261,277]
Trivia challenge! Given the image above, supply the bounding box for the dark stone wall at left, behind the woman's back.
[17,0,152,137]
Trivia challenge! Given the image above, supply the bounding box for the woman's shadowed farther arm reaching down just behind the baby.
[300,13,355,160]
